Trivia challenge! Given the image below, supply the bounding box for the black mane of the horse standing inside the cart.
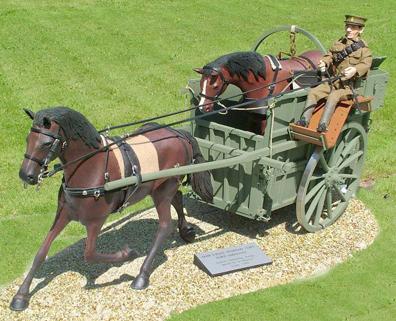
[203,51,265,81]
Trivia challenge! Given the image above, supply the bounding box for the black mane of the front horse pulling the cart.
[33,106,101,148]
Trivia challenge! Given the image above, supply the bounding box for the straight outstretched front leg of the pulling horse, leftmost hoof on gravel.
[10,210,70,311]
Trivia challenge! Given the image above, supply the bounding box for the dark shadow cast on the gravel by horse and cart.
[31,199,296,295]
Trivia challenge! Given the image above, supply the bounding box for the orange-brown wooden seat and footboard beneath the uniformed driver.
[289,96,373,149]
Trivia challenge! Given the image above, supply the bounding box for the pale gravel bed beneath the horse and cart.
[0,200,379,321]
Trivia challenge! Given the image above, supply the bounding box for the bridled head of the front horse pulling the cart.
[19,109,65,185]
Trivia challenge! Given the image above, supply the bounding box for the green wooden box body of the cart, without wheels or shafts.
[188,58,388,220]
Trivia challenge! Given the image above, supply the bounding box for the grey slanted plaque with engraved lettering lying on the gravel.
[194,243,272,276]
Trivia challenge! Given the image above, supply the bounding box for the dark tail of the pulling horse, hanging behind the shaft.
[179,130,213,203]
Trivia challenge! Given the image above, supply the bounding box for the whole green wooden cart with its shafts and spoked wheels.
[104,26,388,232]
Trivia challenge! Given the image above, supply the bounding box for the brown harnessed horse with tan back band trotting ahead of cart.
[10,107,213,311]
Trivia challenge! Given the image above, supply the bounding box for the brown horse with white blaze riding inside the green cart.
[194,51,323,135]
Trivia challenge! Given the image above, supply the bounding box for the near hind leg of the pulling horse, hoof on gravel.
[131,188,173,290]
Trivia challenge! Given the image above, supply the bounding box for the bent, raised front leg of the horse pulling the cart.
[84,219,136,263]
